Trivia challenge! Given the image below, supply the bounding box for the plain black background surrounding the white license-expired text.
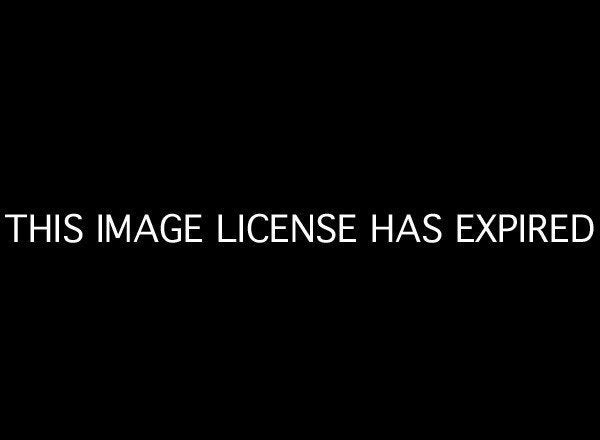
[1,5,598,433]
